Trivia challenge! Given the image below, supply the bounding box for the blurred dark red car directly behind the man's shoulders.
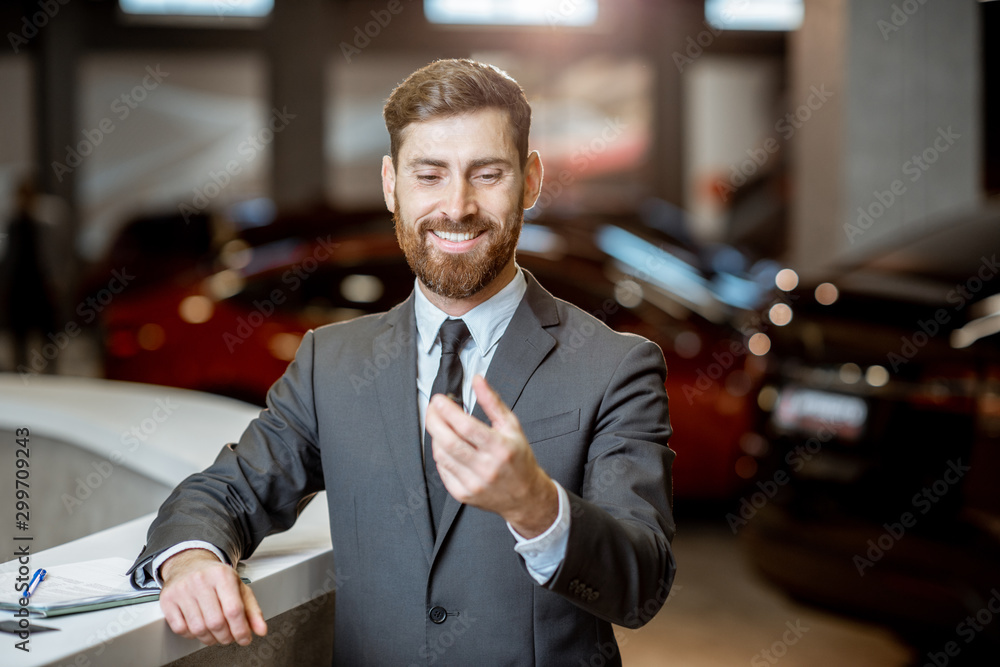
[102,214,772,499]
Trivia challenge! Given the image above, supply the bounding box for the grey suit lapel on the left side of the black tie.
[372,294,436,565]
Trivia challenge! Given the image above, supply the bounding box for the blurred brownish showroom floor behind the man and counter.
[0,334,916,667]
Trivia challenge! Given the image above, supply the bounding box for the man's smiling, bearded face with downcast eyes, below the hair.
[382,109,541,299]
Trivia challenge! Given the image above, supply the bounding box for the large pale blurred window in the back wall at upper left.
[76,51,270,259]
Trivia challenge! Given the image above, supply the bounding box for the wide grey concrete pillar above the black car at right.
[789,0,983,278]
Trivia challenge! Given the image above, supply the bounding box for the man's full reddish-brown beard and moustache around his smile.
[393,201,524,299]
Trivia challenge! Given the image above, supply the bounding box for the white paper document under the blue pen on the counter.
[0,558,160,616]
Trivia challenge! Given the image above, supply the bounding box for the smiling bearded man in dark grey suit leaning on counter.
[133,60,675,665]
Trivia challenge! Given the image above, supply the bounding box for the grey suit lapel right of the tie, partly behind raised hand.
[432,269,559,558]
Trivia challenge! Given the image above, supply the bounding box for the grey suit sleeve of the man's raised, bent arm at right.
[546,341,676,628]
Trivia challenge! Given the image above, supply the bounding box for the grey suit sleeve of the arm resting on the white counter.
[129,331,323,579]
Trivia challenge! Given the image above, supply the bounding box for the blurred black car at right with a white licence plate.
[740,202,1000,664]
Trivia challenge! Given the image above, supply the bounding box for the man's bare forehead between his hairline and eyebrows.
[399,108,517,161]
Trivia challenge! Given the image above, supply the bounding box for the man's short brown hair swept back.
[382,59,531,167]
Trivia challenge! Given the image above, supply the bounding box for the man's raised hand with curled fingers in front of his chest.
[426,375,559,539]
